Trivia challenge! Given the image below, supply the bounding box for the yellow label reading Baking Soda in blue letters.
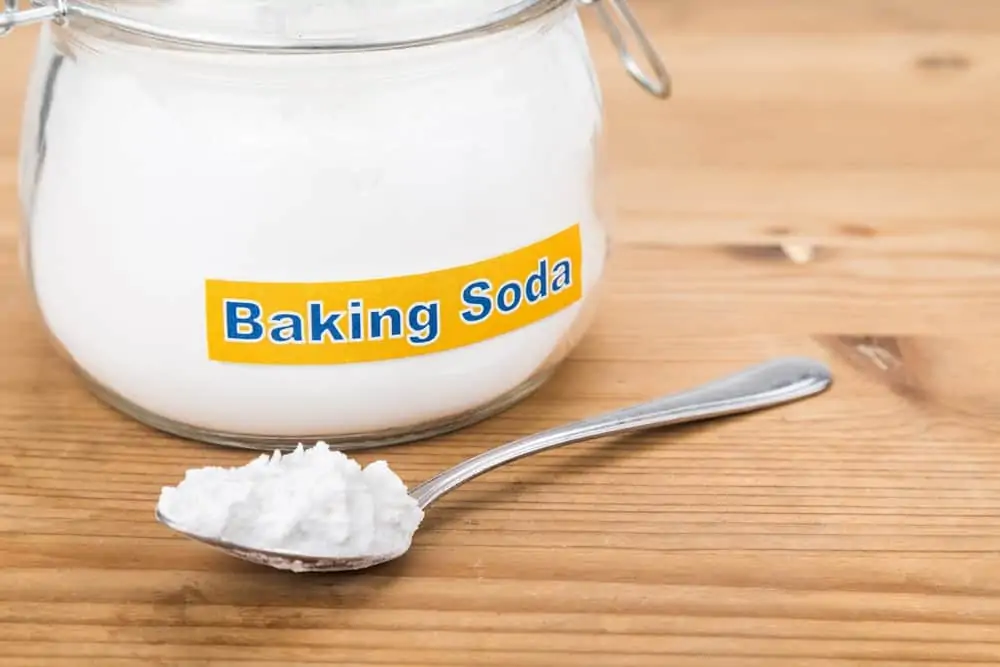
[205,225,582,364]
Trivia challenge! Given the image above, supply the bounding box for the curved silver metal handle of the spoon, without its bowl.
[410,357,832,509]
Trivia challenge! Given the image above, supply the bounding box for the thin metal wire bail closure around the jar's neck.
[0,0,671,99]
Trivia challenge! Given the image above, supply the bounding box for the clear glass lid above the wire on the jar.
[48,0,575,52]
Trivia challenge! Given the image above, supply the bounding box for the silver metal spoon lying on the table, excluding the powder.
[156,357,833,572]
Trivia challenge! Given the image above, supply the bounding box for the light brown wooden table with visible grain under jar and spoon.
[0,0,1000,667]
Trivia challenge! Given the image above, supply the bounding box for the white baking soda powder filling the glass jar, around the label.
[22,0,607,439]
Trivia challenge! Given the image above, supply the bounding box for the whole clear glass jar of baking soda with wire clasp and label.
[0,0,668,449]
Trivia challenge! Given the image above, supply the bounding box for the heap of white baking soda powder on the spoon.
[157,442,424,558]
